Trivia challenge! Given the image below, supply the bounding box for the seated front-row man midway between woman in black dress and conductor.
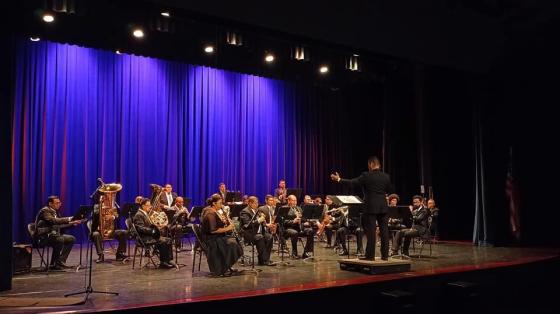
[284,195,314,258]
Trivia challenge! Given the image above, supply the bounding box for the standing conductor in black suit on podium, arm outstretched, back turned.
[331,156,392,260]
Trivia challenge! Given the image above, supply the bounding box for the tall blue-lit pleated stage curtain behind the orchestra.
[12,39,380,241]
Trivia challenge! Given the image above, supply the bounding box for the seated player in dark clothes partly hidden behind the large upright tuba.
[90,195,128,263]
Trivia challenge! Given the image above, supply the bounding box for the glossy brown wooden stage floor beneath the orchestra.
[0,242,558,313]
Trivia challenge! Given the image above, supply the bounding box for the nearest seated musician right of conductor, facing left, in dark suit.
[391,195,430,255]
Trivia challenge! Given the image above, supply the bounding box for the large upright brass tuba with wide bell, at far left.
[98,183,122,240]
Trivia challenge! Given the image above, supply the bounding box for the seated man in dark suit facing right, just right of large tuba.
[133,198,176,268]
